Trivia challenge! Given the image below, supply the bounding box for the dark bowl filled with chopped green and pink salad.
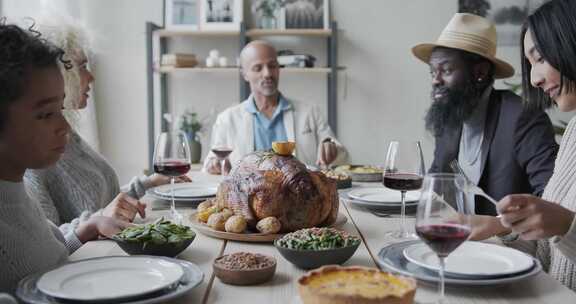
[274,228,360,269]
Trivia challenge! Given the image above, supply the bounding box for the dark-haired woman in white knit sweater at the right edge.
[482,0,576,290]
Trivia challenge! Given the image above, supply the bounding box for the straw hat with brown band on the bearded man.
[412,13,514,78]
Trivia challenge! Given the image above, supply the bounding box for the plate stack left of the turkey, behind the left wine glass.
[148,182,218,202]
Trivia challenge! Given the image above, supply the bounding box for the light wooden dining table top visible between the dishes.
[70,171,576,304]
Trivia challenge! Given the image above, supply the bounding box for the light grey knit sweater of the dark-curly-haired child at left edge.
[0,181,82,293]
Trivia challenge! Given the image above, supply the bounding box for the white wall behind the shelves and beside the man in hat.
[163,0,457,176]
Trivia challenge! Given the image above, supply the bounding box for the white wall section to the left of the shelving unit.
[2,0,162,182]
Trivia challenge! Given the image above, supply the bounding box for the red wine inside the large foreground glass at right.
[416,224,470,258]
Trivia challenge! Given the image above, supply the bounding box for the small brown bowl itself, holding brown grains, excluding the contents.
[212,252,276,285]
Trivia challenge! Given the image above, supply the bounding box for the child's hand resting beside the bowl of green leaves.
[75,216,133,243]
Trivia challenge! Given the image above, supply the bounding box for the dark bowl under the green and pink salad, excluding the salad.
[274,240,361,269]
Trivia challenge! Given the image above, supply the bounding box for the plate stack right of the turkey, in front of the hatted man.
[342,187,420,209]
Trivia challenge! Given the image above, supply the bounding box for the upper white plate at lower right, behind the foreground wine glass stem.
[403,241,534,277]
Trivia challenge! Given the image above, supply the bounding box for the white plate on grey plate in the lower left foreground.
[16,256,204,304]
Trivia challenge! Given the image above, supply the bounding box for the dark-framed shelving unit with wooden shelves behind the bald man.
[146,22,343,168]
